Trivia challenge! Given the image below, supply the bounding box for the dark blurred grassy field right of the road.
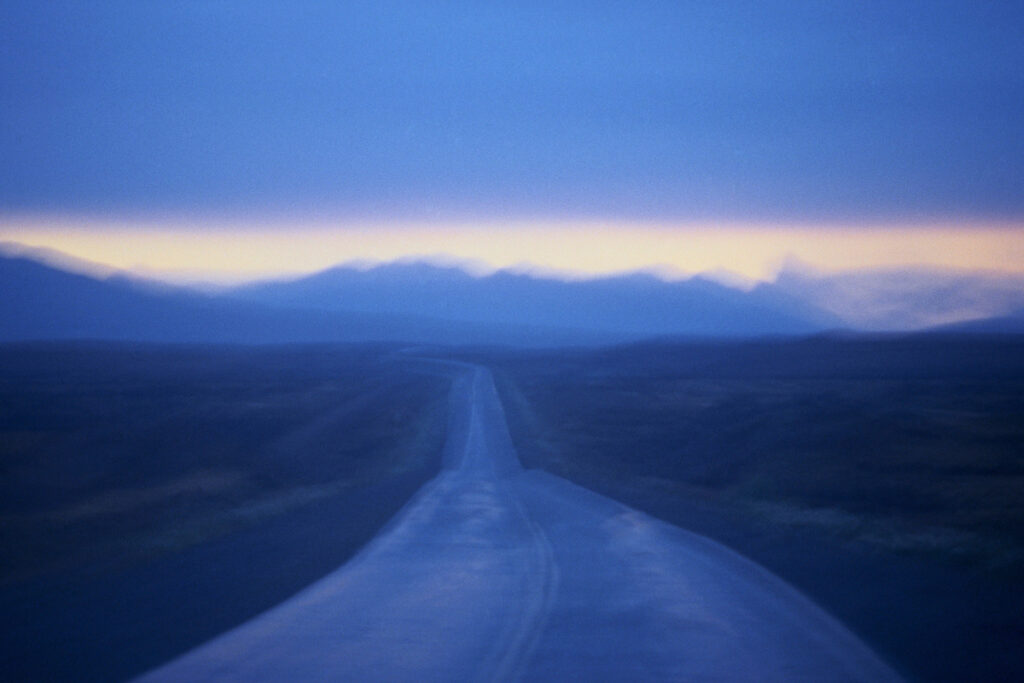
[478,337,1024,680]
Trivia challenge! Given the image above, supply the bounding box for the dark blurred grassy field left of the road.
[0,344,449,680]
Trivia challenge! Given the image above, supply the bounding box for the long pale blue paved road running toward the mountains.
[140,366,899,681]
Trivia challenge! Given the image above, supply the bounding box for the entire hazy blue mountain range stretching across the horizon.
[0,248,1024,345]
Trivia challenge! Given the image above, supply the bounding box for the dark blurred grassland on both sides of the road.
[0,337,1024,680]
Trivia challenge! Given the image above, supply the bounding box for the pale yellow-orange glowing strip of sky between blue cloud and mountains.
[0,219,1024,283]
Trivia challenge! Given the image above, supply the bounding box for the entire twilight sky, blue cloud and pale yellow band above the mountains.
[0,0,1024,276]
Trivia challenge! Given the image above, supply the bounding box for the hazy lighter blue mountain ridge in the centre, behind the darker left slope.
[229,262,842,338]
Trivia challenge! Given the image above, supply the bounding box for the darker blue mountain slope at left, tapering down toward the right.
[0,256,593,344]
